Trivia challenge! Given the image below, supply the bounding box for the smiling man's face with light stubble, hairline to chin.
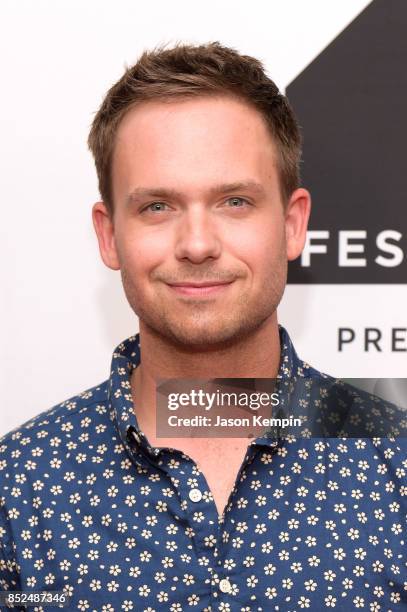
[94,97,308,350]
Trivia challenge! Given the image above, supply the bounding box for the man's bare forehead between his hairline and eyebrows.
[112,96,276,200]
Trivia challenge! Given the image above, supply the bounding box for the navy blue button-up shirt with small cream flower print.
[0,327,407,612]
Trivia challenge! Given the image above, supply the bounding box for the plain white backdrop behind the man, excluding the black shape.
[0,0,407,434]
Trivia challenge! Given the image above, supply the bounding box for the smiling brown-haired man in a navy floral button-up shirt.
[0,43,407,612]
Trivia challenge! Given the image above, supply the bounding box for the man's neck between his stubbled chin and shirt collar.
[131,313,280,437]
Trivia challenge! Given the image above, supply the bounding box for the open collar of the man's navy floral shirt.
[108,325,306,458]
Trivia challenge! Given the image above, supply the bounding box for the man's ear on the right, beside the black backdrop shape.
[285,188,311,261]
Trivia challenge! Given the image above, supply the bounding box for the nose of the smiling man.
[175,205,221,263]
